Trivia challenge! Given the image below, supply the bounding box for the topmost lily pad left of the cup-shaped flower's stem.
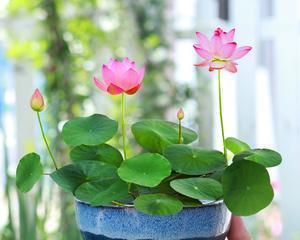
[62,114,118,146]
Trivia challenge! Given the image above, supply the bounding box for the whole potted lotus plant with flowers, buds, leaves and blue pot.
[16,28,281,240]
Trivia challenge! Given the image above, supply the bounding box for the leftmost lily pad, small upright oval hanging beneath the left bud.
[16,153,43,192]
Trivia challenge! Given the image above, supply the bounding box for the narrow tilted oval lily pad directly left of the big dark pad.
[170,178,223,200]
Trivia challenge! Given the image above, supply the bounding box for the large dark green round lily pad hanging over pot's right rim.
[222,161,274,216]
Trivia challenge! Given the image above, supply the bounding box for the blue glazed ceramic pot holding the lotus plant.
[76,201,231,240]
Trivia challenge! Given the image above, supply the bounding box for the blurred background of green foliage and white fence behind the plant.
[0,0,300,240]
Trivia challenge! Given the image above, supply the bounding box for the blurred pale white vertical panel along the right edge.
[273,0,300,239]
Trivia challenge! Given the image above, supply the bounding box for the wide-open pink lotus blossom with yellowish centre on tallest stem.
[194,28,252,73]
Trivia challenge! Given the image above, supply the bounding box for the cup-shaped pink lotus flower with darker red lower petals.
[94,58,145,95]
